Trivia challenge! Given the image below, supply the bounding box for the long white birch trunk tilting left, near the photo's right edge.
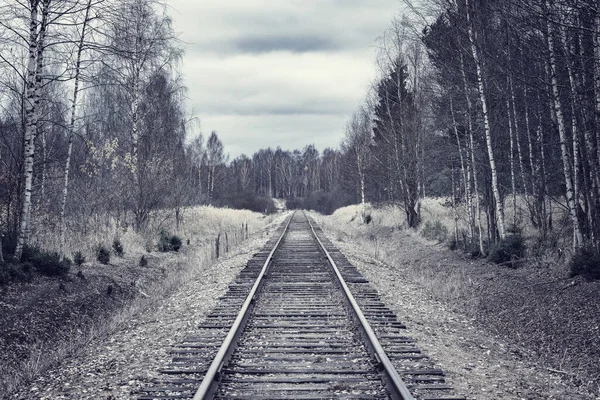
[546,5,583,249]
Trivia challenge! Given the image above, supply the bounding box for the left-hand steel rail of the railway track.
[193,211,296,400]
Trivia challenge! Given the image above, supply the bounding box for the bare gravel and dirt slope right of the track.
[313,214,600,400]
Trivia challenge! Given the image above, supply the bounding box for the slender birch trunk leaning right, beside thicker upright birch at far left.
[58,0,92,261]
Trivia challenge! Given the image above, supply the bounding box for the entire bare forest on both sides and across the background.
[0,0,600,275]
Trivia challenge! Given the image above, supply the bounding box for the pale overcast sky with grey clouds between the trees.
[167,0,399,158]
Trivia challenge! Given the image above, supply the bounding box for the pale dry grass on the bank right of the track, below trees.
[317,198,566,301]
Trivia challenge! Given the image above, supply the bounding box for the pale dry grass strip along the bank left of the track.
[0,206,281,398]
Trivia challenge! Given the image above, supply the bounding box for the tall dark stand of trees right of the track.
[345,0,600,254]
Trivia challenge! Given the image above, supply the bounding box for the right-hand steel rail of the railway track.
[302,211,414,400]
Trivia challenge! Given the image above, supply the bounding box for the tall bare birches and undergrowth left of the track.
[0,0,189,260]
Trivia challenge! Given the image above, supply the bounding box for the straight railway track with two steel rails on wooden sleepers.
[138,212,465,400]
